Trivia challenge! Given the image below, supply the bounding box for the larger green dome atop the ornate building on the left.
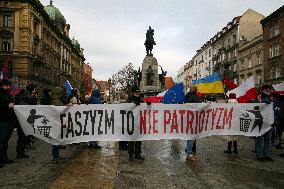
[44,1,66,31]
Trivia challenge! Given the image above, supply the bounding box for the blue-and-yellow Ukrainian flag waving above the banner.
[192,73,224,93]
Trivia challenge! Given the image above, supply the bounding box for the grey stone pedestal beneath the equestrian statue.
[140,56,161,96]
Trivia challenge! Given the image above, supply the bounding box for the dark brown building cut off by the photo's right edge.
[261,6,284,83]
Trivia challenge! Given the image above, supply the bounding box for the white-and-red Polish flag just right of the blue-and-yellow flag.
[226,77,257,103]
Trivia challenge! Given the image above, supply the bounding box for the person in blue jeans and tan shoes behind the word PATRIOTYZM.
[185,86,202,161]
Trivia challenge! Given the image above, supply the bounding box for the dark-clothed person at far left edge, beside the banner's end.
[0,79,15,168]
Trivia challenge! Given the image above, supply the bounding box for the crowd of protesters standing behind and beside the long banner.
[0,79,284,168]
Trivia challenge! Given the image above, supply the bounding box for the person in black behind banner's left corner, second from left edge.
[15,89,29,159]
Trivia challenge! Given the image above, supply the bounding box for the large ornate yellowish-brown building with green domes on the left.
[0,0,85,90]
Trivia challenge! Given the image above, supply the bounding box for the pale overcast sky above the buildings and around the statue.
[41,0,284,80]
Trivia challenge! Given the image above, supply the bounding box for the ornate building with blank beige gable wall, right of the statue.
[210,9,264,83]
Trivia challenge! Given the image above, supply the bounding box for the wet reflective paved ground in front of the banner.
[0,132,284,189]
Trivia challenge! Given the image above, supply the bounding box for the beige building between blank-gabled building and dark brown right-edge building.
[237,35,264,86]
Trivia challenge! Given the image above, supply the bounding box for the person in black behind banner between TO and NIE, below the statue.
[127,86,144,161]
